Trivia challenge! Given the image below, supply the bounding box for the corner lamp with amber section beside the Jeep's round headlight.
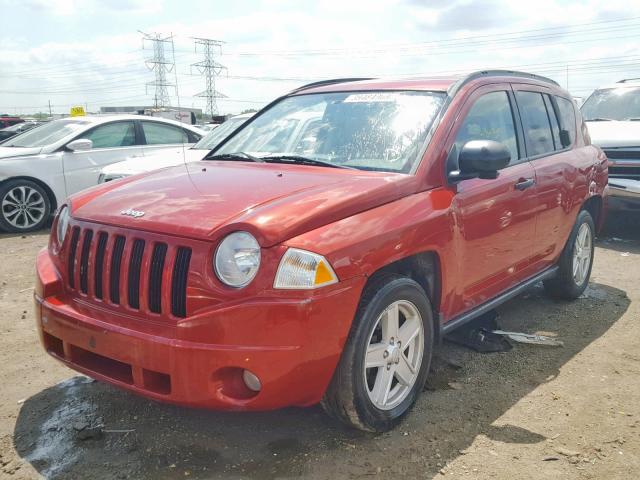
[273,248,338,289]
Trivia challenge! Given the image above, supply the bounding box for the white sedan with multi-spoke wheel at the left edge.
[0,115,203,232]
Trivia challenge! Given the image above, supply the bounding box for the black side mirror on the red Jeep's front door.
[449,140,511,181]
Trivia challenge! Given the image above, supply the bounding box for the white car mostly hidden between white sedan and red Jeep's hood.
[98,114,253,183]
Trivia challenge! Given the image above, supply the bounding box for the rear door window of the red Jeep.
[516,91,554,157]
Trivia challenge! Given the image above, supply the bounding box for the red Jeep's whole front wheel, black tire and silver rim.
[321,275,433,432]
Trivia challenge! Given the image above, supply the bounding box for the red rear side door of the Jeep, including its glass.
[513,84,586,270]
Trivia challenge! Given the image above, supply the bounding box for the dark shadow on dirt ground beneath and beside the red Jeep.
[13,284,629,479]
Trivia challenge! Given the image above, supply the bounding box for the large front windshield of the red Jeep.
[214,91,445,173]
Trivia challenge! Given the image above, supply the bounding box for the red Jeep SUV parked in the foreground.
[36,71,607,431]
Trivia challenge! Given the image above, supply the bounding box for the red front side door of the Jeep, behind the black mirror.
[452,84,536,310]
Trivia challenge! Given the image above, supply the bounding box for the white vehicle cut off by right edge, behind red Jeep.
[581,79,640,210]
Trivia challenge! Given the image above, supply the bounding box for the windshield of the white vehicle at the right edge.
[580,87,640,121]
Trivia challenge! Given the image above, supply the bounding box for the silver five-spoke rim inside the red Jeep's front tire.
[363,300,424,410]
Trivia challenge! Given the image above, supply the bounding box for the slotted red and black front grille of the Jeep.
[66,226,192,318]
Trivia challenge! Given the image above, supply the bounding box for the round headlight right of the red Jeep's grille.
[213,232,260,287]
